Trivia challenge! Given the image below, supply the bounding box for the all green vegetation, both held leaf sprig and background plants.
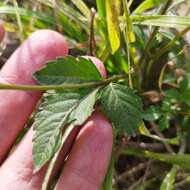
[0,0,190,190]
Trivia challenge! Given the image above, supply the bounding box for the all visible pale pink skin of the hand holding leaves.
[0,22,113,190]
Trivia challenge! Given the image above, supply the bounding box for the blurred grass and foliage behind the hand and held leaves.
[0,0,190,190]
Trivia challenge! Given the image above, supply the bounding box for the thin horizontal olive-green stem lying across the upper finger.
[0,75,125,91]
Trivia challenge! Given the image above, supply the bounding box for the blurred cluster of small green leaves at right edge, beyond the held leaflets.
[143,69,190,131]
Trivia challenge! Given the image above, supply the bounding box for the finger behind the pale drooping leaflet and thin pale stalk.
[0,127,78,190]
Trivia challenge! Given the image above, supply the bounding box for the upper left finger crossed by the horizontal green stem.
[0,30,68,163]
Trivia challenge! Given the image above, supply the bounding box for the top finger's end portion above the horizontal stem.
[1,30,68,84]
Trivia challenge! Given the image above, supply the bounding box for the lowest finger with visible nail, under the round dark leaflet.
[56,113,113,190]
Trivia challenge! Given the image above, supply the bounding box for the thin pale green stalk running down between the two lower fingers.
[41,125,75,190]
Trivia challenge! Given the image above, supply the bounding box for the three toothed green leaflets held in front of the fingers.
[33,56,142,171]
